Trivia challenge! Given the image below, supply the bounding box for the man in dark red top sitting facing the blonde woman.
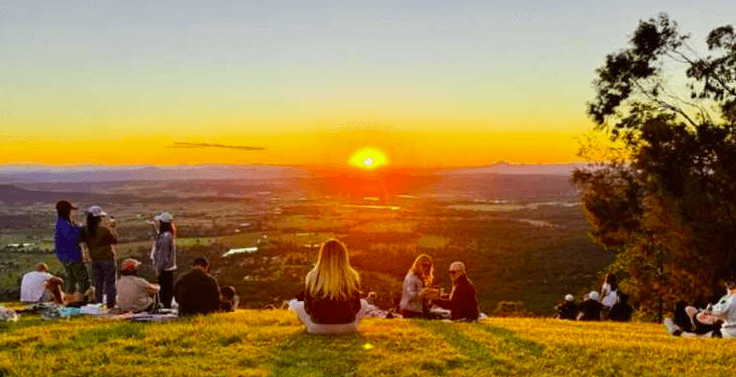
[432,262,479,321]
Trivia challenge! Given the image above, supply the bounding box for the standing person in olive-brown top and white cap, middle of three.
[81,205,118,309]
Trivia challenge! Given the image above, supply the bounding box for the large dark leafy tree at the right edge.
[573,14,736,313]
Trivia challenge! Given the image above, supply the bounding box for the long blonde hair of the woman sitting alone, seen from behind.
[305,239,360,299]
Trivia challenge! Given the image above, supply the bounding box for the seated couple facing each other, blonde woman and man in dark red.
[399,254,480,321]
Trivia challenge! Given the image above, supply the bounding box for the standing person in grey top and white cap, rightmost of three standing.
[151,212,178,309]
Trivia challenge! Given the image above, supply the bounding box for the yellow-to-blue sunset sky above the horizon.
[0,0,736,167]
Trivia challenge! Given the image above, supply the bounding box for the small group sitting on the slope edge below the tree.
[555,274,634,322]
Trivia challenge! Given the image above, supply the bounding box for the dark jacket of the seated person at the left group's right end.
[174,268,220,316]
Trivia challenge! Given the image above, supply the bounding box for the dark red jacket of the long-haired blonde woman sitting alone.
[304,290,361,324]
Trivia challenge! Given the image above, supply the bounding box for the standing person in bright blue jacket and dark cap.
[54,200,90,301]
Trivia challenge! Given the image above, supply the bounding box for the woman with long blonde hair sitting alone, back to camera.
[289,239,368,334]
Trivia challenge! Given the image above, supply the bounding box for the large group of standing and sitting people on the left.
[21,200,238,315]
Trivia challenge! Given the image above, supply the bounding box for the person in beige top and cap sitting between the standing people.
[116,258,161,313]
